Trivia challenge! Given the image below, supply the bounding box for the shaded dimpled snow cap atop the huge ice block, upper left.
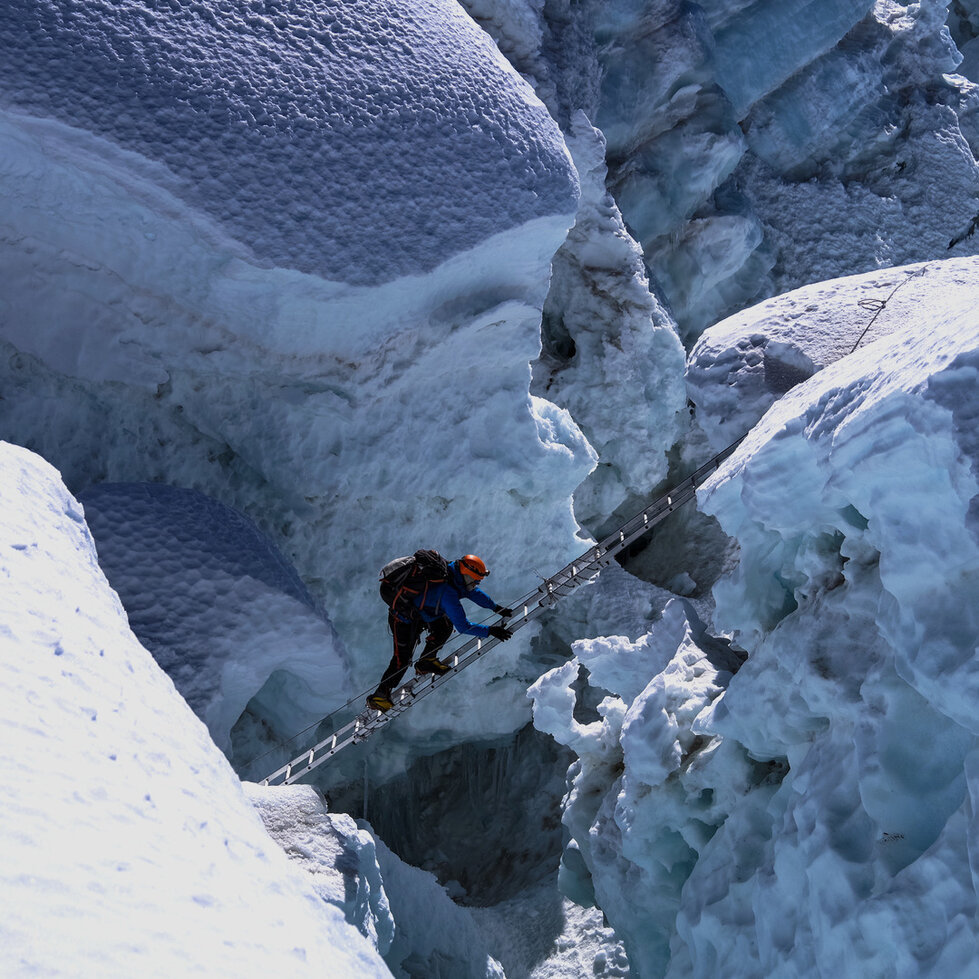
[0,0,576,284]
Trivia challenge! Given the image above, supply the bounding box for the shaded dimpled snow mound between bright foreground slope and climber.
[79,483,347,751]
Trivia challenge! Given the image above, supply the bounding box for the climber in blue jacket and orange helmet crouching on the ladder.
[367,551,513,711]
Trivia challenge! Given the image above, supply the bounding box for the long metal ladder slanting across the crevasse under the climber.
[261,436,745,785]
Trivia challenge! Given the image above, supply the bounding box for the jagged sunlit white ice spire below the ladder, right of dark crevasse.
[528,600,752,976]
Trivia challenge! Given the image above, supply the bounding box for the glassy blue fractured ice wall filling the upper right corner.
[582,0,979,344]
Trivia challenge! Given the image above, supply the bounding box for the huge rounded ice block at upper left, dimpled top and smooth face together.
[0,0,593,756]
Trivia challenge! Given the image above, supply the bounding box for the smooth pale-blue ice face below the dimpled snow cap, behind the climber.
[0,13,595,764]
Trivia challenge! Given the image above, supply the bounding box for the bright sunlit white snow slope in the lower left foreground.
[0,443,389,979]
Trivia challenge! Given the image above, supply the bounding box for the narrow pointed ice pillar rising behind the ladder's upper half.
[533,112,684,536]
